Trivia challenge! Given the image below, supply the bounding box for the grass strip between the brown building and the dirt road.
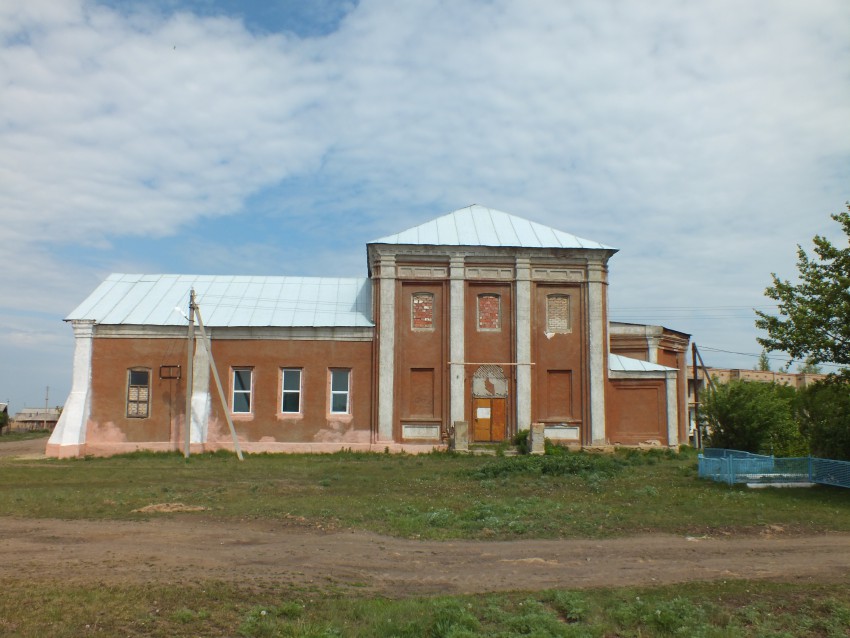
[0,451,850,539]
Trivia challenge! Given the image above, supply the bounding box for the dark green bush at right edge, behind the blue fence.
[795,379,850,461]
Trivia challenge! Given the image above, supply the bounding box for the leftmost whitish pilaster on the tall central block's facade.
[378,255,396,442]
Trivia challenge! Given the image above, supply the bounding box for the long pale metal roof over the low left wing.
[71,274,374,327]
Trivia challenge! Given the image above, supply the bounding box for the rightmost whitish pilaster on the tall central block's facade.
[587,262,608,445]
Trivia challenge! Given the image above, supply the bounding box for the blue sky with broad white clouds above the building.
[0,0,850,412]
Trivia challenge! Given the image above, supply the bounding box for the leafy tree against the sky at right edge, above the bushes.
[756,204,850,376]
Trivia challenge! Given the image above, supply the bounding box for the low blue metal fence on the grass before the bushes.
[699,448,850,487]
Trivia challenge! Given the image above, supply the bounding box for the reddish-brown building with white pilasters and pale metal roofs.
[47,206,689,456]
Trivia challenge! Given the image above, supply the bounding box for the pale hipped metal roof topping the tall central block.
[369,204,616,250]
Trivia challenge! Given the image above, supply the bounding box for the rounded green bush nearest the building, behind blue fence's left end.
[700,379,808,456]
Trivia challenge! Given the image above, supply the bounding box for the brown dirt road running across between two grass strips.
[0,515,850,597]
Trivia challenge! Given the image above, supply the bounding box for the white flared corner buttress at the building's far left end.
[47,320,94,457]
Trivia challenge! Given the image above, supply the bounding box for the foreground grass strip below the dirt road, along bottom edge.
[0,581,850,638]
